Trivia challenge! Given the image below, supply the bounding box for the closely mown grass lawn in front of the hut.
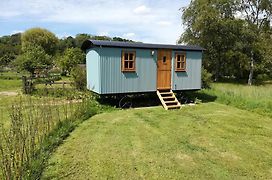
[42,103,272,179]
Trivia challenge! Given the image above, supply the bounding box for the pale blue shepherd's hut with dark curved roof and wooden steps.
[82,40,204,109]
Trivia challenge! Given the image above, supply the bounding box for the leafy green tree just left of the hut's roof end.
[57,48,85,75]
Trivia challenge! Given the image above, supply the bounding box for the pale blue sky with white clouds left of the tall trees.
[0,0,190,44]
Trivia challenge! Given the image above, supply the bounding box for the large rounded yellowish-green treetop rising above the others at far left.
[21,28,58,55]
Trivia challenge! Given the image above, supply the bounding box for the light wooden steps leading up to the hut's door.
[157,89,181,110]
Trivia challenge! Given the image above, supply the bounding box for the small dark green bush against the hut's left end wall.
[71,66,87,91]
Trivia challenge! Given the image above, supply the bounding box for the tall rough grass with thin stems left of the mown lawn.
[0,97,100,179]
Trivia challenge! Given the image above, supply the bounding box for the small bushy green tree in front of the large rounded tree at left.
[15,46,52,75]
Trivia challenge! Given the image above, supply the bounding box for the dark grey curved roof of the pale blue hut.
[81,40,205,51]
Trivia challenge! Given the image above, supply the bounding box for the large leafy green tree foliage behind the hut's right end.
[180,0,272,80]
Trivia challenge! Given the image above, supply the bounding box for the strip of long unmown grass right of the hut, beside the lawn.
[200,83,272,117]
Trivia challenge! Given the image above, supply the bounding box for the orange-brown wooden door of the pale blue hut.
[157,49,172,89]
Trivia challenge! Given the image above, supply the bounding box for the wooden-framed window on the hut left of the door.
[122,51,136,72]
